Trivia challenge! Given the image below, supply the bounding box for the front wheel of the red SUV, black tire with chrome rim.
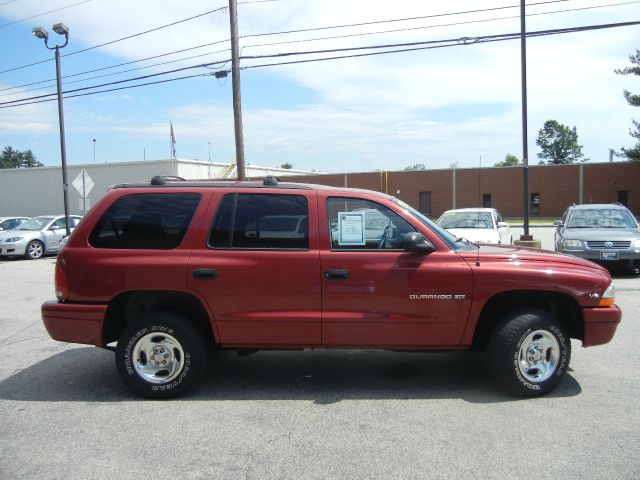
[487,310,571,397]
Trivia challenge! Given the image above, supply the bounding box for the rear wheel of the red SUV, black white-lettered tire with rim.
[116,311,206,398]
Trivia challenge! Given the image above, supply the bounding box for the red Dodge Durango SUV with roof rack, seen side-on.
[42,177,621,398]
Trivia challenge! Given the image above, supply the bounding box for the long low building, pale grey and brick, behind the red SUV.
[0,160,640,218]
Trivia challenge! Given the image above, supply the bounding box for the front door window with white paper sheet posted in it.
[327,198,416,250]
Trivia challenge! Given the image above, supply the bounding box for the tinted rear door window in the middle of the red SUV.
[209,193,309,250]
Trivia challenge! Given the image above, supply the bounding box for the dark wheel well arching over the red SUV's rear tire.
[103,291,215,347]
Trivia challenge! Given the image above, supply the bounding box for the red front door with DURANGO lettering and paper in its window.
[321,197,472,348]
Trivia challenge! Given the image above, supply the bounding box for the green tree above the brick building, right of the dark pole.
[536,120,588,165]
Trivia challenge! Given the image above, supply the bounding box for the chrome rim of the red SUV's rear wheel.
[133,332,184,384]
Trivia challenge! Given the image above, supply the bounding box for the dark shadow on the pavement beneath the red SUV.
[0,347,582,405]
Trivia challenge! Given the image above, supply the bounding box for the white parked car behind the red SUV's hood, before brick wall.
[436,208,513,245]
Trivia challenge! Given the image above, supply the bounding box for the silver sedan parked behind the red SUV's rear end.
[0,215,82,260]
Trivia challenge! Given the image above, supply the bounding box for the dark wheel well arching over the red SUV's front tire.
[472,291,584,350]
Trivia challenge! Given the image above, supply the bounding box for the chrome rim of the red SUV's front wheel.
[518,330,560,383]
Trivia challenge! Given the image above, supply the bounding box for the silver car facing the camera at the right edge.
[554,203,640,269]
